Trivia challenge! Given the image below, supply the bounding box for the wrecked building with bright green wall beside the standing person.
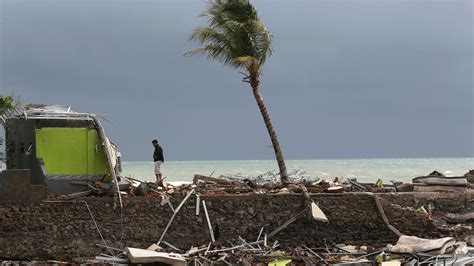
[1,104,121,195]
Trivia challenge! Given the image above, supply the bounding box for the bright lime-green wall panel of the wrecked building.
[36,128,107,175]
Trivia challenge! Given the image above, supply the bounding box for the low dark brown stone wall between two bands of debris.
[0,193,470,260]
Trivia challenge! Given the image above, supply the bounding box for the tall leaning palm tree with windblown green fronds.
[186,0,288,184]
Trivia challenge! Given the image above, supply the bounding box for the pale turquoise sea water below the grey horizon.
[123,158,474,182]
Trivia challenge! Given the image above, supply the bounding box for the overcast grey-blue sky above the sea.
[0,0,474,161]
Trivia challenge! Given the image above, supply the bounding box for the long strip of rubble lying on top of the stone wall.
[48,169,474,200]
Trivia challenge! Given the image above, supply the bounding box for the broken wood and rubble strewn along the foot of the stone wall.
[90,235,474,266]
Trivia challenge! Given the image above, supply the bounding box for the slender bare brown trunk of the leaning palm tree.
[252,82,289,184]
